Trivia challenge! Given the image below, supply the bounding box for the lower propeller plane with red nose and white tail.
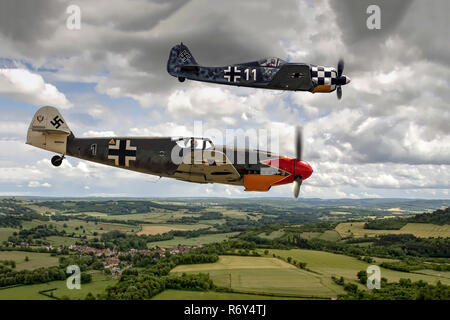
[26,107,313,198]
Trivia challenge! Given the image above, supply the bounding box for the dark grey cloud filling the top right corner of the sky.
[329,0,450,72]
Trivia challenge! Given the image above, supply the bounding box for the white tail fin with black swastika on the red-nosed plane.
[26,107,72,154]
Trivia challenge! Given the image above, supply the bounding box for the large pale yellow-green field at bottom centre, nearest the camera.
[172,256,343,298]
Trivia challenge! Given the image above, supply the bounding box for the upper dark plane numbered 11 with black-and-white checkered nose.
[167,43,350,99]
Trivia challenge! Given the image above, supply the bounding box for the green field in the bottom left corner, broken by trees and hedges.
[0,272,117,300]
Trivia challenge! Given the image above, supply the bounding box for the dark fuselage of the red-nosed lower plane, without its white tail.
[66,134,312,191]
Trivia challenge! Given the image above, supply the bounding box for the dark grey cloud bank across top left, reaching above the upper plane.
[0,0,304,95]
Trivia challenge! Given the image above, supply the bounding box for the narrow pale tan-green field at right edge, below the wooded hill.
[336,222,450,238]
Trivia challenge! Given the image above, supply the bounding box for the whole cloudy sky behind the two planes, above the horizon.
[0,0,450,199]
